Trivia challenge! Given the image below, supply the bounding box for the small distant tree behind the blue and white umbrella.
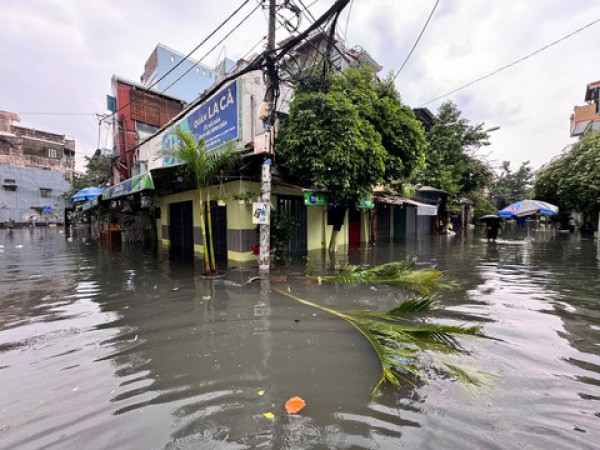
[491,161,533,210]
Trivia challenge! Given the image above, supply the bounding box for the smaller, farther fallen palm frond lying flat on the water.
[310,260,457,295]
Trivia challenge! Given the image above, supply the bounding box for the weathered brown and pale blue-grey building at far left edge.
[0,111,75,224]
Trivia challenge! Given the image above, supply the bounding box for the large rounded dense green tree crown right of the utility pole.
[277,68,426,203]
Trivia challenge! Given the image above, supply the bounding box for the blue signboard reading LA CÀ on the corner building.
[162,81,239,165]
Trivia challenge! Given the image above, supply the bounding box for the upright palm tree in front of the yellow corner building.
[164,129,240,275]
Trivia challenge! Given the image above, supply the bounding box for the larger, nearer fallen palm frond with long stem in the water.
[274,289,481,395]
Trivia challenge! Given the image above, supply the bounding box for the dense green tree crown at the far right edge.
[534,132,600,216]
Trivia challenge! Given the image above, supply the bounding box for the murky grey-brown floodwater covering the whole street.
[0,228,600,449]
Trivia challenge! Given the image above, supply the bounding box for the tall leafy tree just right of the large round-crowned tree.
[415,101,492,195]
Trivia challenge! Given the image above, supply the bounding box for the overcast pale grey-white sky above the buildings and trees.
[0,0,600,174]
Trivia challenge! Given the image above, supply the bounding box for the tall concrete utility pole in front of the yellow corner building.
[258,0,277,275]
